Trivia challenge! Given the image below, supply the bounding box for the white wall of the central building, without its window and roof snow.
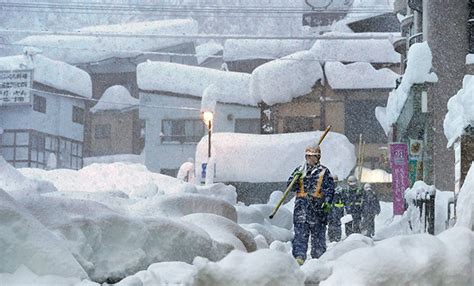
[140,92,260,172]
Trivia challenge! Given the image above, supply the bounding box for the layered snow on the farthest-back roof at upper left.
[16,19,198,64]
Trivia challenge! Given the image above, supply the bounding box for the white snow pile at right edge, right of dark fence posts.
[456,162,474,230]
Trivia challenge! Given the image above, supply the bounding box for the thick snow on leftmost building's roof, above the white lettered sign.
[0,52,92,98]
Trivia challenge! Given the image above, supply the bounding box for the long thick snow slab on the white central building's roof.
[137,61,257,106]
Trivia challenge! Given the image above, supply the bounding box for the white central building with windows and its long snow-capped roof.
[137,62,260,175]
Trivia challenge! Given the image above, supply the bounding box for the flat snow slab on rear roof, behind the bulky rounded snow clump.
[224,39,313,62]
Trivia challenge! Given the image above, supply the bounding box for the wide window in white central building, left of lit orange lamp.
[161,119,204,143]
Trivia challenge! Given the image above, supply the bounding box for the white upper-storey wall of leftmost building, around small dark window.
[0,91,85,142]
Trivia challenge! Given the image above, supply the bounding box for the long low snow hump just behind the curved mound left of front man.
[130,194,237,222]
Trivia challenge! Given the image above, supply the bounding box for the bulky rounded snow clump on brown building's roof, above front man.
[250,51,323,105]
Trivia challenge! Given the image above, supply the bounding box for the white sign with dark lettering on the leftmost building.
[0,70,33,105]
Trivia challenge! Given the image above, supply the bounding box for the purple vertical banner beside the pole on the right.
[389,143,410,215]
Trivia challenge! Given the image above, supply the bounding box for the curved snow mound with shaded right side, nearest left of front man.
[181,213,257,252]
